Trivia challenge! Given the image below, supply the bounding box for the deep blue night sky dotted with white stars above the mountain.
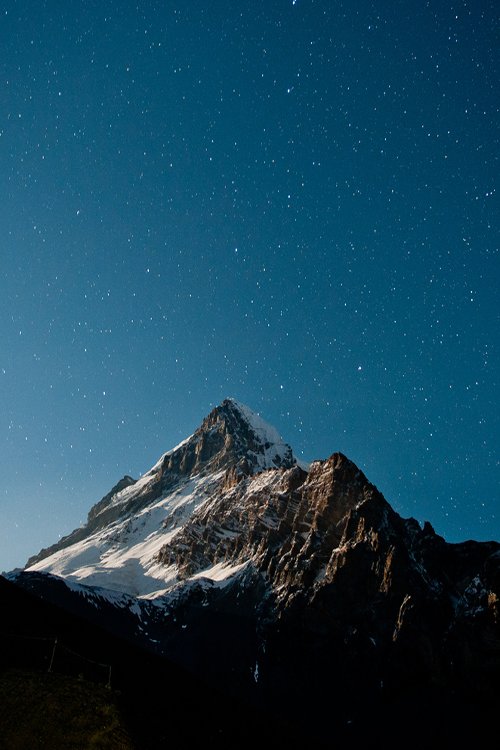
[0,0,500,569]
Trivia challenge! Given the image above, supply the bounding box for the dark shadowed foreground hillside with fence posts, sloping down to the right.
[0,577,293,750]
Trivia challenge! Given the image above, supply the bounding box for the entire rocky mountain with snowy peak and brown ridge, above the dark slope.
[10,399,500,746]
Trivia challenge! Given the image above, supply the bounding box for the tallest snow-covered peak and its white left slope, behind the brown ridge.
[27,398,296,596]
